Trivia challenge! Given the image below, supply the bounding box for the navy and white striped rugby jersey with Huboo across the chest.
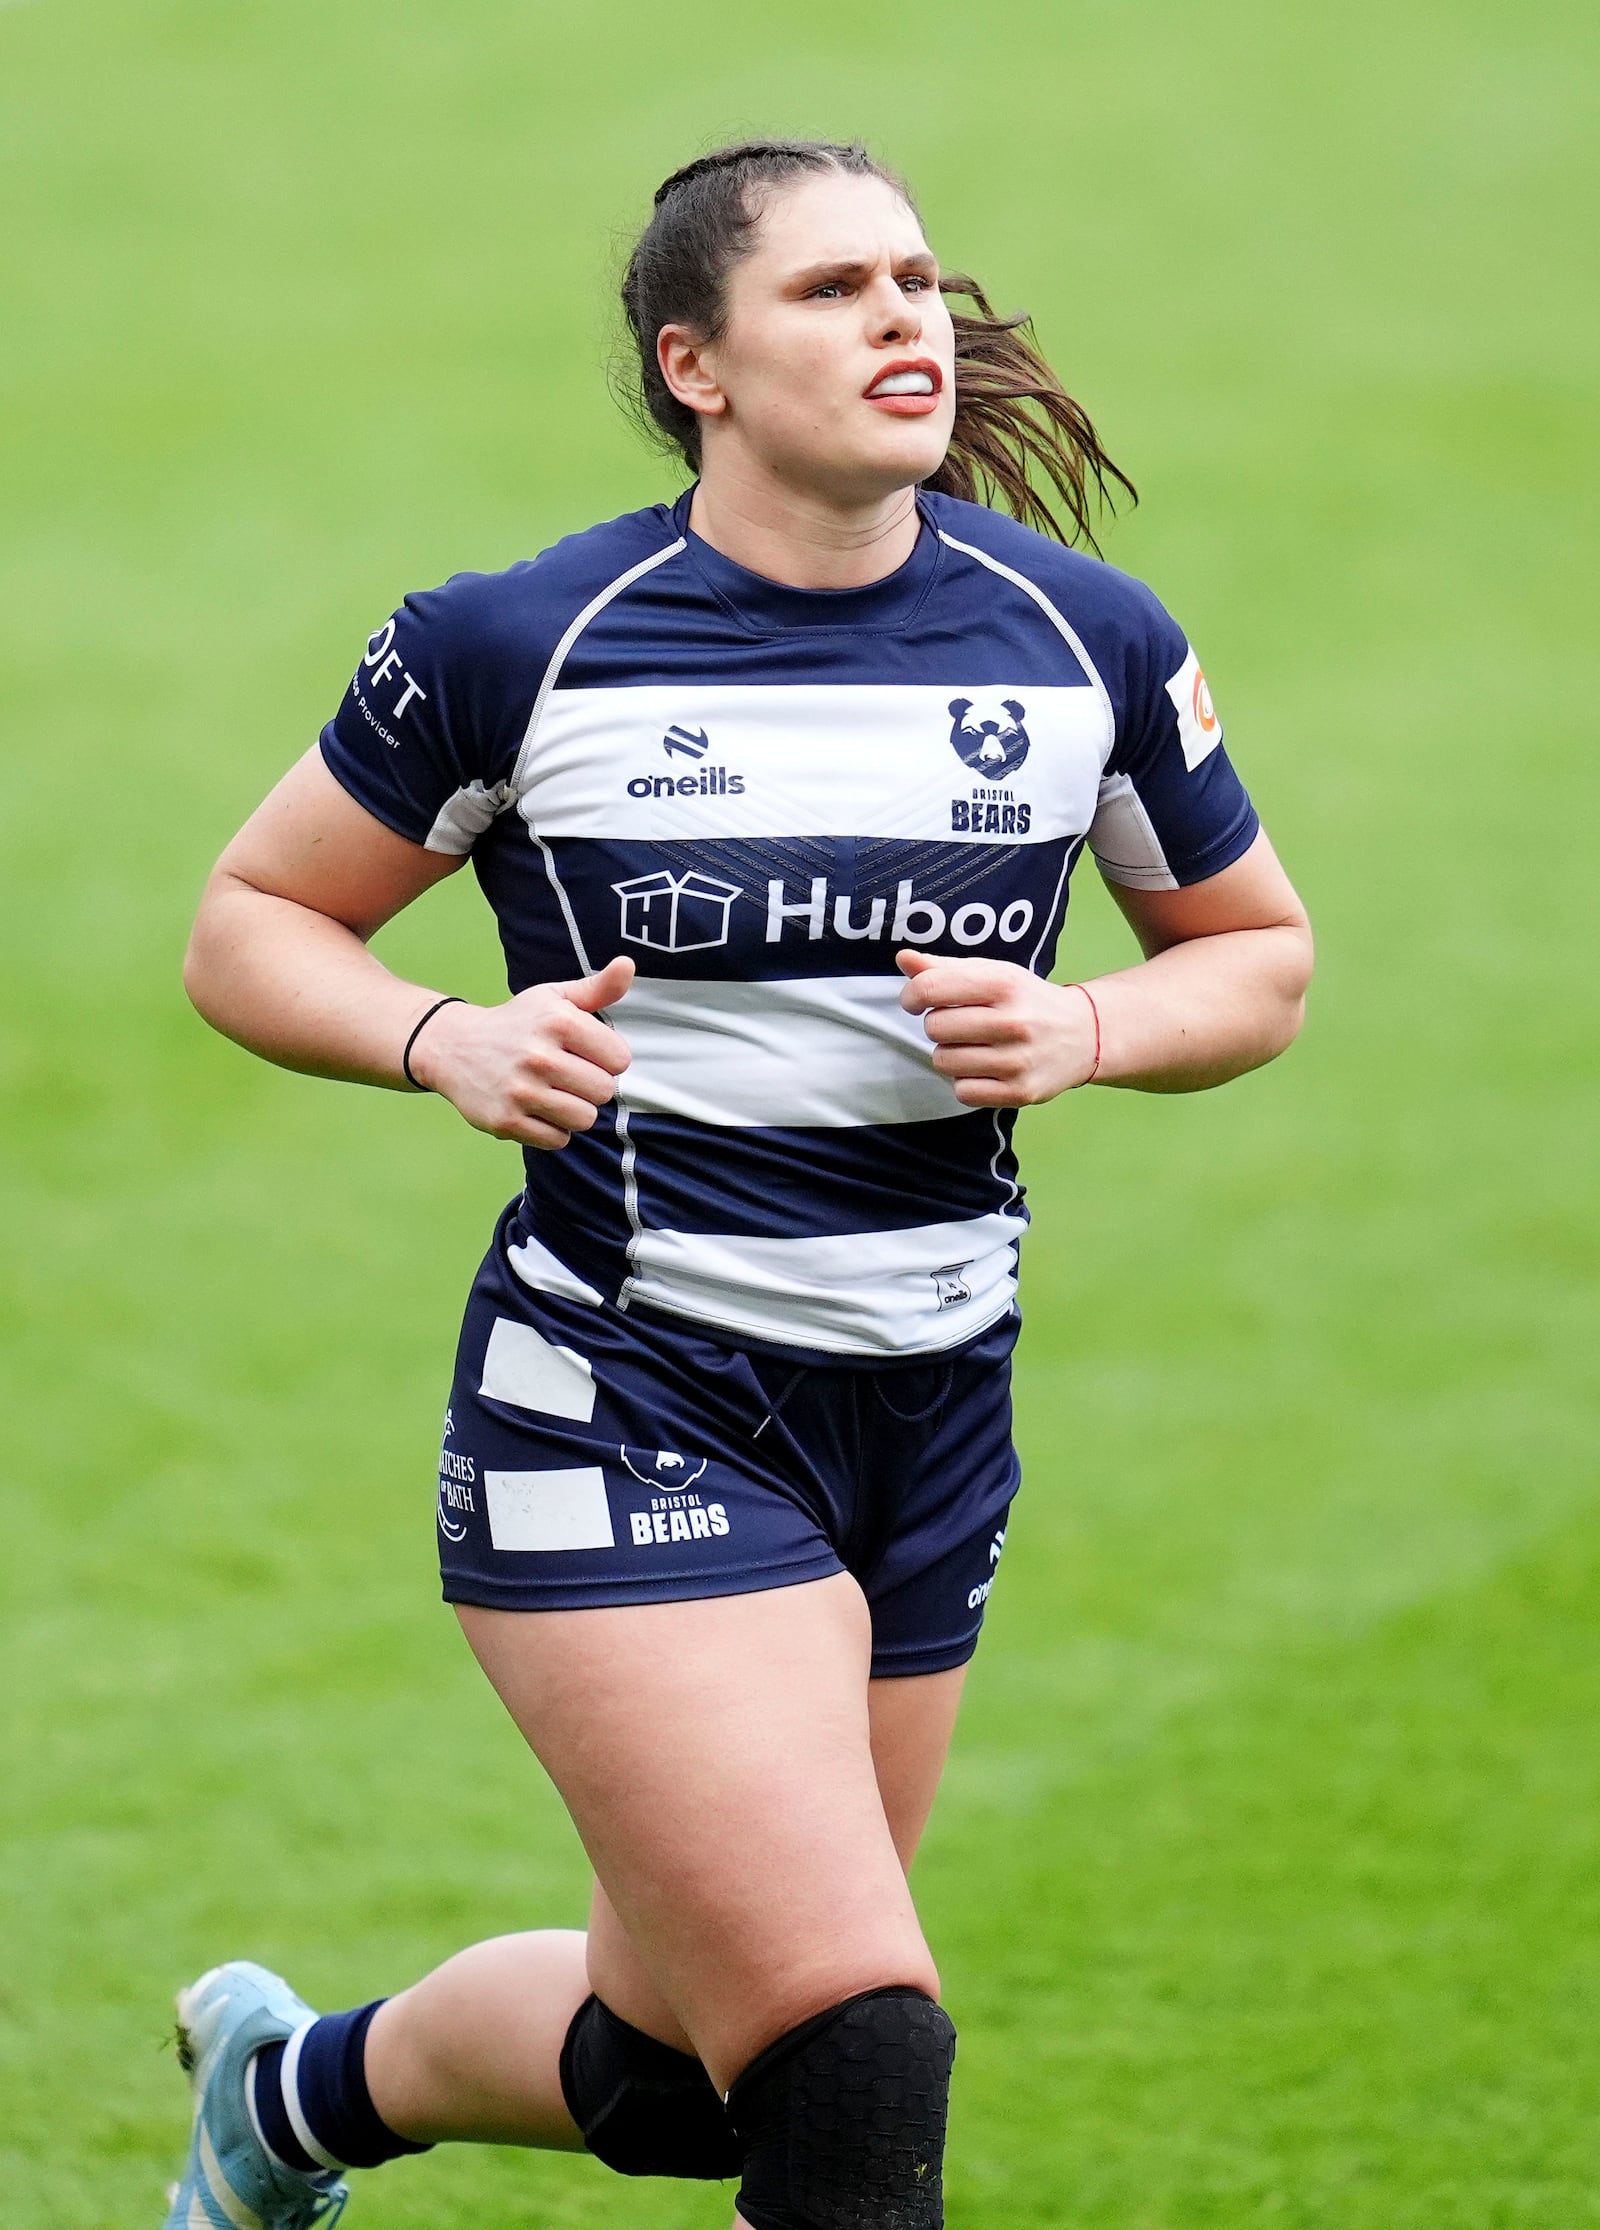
[321,493,1256,1358]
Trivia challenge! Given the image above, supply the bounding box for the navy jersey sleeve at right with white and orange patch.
[1089,582,1261,890]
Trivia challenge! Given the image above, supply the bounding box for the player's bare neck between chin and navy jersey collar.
[690,471,919,589]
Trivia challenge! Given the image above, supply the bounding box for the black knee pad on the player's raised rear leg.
[560,1998,739,2176]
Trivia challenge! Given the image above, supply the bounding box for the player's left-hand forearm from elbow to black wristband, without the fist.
[183,870,440,1090]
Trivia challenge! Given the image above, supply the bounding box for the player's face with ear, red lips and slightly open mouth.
[661,172,955,506]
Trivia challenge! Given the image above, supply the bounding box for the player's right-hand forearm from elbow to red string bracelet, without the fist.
[1087,923,1312,1093]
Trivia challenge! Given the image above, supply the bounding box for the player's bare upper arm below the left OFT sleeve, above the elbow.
[210,745,462,937]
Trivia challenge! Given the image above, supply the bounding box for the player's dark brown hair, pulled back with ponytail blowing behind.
[623,140,1138,551]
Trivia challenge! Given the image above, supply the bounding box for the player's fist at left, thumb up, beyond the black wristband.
[411,959,634,1153]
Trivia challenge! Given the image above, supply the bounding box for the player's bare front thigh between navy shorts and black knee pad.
[457,1574,937,2090]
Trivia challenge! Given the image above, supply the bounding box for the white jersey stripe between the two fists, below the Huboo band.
[609,975,966,1131]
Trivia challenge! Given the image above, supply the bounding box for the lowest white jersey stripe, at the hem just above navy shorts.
[618,1213,1026,1356]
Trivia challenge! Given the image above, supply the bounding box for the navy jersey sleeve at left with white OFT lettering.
[321,566,540,854]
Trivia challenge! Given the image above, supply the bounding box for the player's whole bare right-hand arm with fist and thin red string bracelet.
[899,836,1312,1106]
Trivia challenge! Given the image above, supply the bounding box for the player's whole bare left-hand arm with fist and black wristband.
[183,749,634,1148]
